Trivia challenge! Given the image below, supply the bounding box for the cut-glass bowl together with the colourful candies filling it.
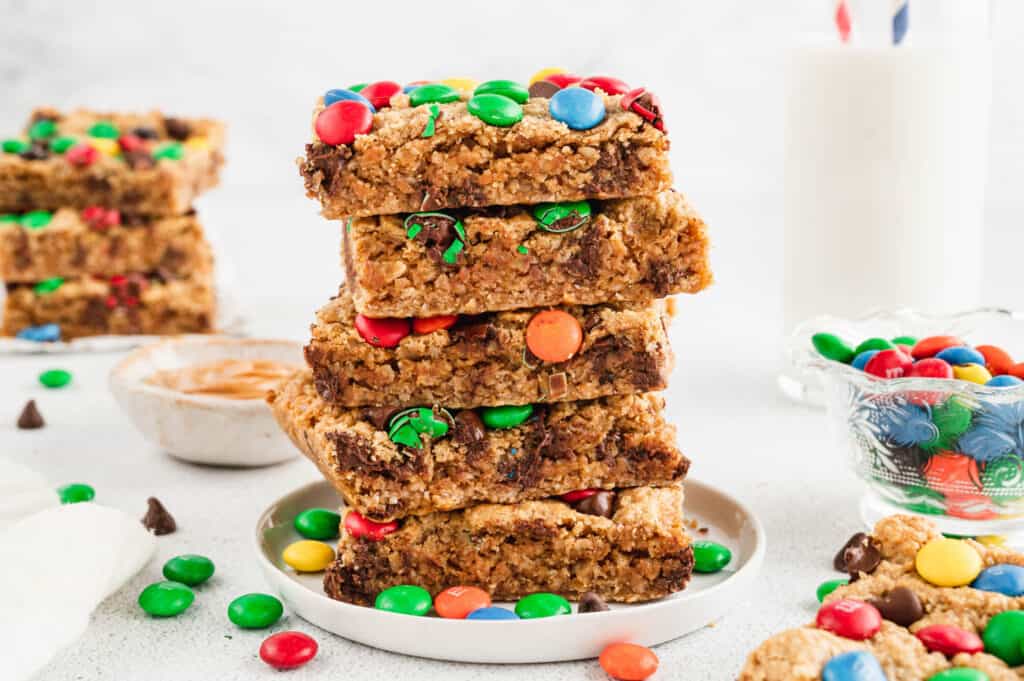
[802,310,1024,536]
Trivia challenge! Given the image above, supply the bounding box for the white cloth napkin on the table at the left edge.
[0,459,157,681]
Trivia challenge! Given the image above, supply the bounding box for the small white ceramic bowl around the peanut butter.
[111,336,303,467]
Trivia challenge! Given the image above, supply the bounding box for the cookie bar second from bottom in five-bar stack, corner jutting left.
[268,371,689,522]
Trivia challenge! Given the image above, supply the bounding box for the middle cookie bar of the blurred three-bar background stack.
[0,206,210,283]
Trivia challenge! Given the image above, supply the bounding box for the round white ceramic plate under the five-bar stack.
[256,479,765,663]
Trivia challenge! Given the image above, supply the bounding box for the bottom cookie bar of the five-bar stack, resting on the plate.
[324,484,693,605]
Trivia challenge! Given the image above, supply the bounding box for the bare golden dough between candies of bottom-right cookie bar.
[739,515,1024,681]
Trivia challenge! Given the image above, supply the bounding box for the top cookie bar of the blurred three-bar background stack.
[0,109,224,215]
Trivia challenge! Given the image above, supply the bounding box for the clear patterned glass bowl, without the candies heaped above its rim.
[787,308,1024,543]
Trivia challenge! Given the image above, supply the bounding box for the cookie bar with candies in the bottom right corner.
[739,516,1024,681]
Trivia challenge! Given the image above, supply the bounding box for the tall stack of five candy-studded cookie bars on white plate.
[269,75,711,604]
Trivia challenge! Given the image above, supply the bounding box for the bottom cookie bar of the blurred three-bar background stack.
[0,270,216,340]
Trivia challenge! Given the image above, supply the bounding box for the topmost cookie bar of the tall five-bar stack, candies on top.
[299,79,672,219]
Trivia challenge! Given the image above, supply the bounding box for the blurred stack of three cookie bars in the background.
[0,109,223,341]
